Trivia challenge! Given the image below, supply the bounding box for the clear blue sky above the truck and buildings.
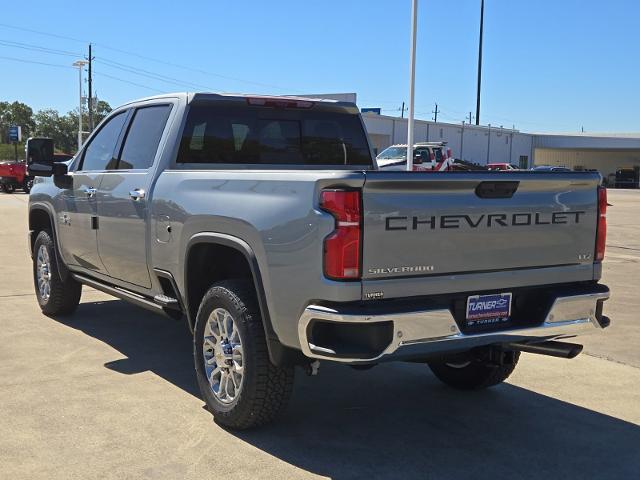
[0,0,640,132]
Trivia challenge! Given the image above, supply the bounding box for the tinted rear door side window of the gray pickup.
[118,105,171,170]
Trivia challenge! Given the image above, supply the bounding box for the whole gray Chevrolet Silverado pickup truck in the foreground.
[29,93,609,429]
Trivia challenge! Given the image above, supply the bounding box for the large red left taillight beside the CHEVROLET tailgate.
[320,190,362,280]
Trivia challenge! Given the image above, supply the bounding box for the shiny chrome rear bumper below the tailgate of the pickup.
[298,291,609,363]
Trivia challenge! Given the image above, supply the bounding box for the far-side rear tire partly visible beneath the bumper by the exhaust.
[429,352,520,390]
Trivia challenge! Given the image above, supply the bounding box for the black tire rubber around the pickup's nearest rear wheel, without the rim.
[193,280,294,430]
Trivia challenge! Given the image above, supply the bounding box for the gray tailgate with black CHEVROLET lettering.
[362,172,600,288]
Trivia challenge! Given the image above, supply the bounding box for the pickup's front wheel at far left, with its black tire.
[33,230,82,316]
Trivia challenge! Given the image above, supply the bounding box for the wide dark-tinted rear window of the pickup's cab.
[177,103,372,166]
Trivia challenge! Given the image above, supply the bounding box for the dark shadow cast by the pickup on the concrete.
[64,301,640,479]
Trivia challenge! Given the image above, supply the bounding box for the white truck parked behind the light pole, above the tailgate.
[376,142,453,171]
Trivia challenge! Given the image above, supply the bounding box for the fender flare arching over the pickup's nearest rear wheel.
[183,232,297,365]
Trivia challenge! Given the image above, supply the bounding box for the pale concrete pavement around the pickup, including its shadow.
[0,191,640,479]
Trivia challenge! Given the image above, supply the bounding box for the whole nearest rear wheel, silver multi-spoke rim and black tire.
[193,280,294,430]
